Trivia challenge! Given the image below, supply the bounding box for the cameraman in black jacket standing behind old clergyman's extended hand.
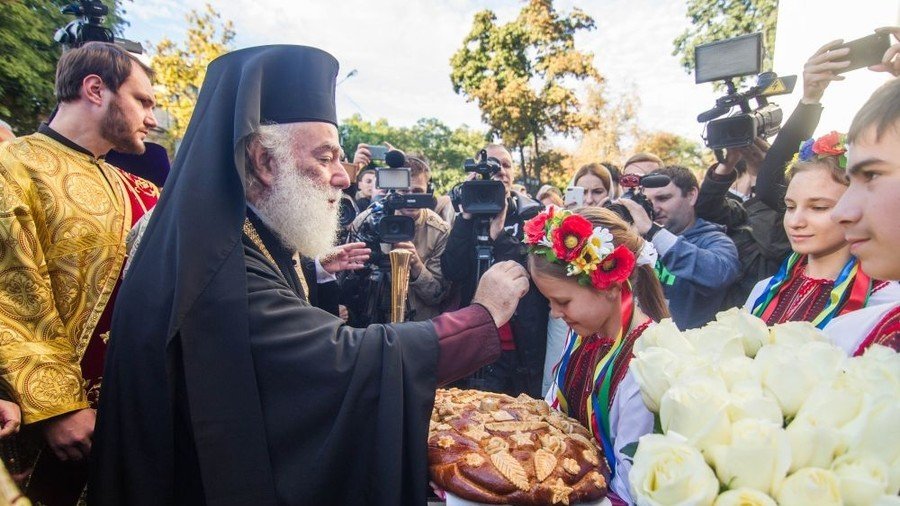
[441,144,549,398]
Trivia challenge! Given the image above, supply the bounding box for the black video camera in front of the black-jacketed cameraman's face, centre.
[450,149,506,216]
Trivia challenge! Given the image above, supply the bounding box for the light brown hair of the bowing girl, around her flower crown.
[528,207,669,321]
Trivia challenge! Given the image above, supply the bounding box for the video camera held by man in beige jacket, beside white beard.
[355,150,435,252]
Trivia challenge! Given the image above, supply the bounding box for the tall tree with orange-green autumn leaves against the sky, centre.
[450,0,601,188]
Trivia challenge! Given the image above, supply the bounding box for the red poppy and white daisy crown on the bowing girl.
[524,206,636,290]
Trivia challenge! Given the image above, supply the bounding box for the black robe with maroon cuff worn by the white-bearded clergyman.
[97,219,500,505]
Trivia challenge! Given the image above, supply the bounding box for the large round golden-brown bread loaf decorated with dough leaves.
[428,388,609,506]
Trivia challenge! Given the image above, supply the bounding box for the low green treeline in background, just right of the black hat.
[338,114,485,194]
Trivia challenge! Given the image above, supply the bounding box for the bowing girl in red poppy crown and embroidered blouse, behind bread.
[525,207,669,502]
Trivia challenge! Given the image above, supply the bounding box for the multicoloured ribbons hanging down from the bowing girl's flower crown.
[553,282,634,474]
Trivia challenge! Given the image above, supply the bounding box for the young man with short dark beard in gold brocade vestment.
[0,43,159,504]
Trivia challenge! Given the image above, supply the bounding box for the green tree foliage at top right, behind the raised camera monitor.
[672,0,778,86]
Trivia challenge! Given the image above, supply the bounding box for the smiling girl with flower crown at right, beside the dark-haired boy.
[745,132,900,344]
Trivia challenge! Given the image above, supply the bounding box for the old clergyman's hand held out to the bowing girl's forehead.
[472,260,528,327]
